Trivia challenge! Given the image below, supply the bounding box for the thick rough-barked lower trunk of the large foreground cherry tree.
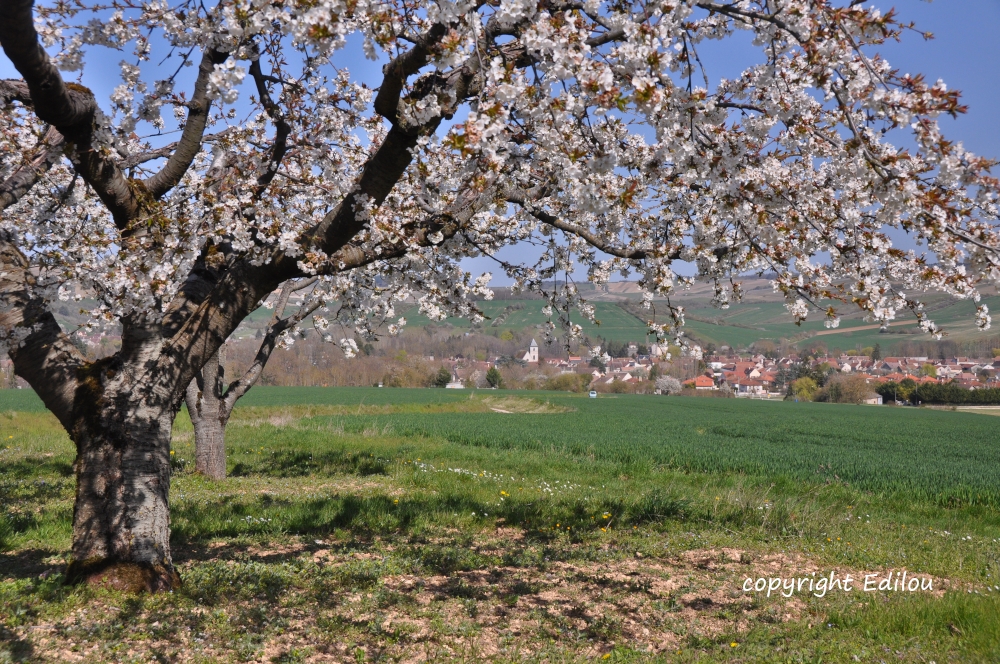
[66,362,180,592]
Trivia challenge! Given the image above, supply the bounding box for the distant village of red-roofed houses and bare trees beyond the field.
[9,322,1000,404]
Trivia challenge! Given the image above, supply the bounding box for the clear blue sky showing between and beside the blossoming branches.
[0,0,1000,286]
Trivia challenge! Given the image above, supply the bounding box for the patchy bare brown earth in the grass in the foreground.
[13,544,960,662]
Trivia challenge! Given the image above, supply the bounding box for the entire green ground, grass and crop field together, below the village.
[0,388,1000,663]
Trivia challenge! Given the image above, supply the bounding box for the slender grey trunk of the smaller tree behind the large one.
[184,351,231,480]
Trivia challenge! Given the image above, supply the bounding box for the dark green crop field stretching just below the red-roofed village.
[296,388,1000,507]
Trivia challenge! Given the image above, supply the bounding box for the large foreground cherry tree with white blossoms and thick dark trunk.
[0,0,1000,590]
